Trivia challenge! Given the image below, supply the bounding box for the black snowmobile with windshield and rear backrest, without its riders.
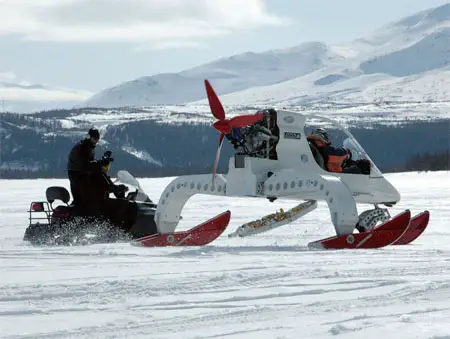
[23,170,157,245]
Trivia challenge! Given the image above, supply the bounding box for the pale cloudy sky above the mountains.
[0,0,449,100]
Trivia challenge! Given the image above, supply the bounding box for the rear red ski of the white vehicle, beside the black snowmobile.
[132,211,231,247]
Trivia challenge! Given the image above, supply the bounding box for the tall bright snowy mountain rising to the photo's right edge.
[196,4,450,105]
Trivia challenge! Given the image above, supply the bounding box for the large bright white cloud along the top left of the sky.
[0,0,287,47]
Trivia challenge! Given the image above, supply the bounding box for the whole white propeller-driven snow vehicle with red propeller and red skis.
[132,80,430,249]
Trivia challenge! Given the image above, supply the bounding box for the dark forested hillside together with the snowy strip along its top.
[0,103,450,178]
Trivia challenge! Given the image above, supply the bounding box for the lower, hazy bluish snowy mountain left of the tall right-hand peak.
[85,42,343,107]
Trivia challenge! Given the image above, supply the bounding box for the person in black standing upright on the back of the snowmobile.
[67,128,115,216]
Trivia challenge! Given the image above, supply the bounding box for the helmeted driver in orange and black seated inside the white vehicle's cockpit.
[307,127,370,174]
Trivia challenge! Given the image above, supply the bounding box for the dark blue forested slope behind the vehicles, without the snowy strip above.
[0,112,450,179]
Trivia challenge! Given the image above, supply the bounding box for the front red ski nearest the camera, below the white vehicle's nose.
[308,210,411,249]
